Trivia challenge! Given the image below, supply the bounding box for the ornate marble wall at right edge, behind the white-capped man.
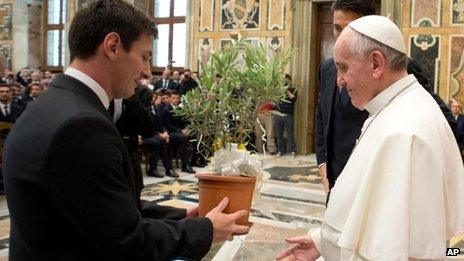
[402,0,464,102]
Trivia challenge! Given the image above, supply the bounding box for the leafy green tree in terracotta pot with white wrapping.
[176,35,292,224]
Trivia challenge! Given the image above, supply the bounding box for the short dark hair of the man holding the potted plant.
[68,0,158,61]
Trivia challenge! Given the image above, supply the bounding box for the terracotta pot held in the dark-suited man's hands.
[195,173,256,225]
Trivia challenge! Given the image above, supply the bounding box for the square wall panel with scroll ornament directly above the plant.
[221,0,261,30]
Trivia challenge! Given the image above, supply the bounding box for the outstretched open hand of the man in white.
[276,235,321,261]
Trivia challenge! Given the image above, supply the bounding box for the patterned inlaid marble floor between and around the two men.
[0,152,464,261]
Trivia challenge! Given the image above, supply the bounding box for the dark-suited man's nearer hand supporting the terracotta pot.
[206,198,250,242]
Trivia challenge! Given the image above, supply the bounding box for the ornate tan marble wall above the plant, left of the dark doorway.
[189,0,292,70]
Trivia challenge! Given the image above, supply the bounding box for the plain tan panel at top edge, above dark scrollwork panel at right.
[411,0,441,27]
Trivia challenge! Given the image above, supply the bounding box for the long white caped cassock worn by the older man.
[311,75,464,261]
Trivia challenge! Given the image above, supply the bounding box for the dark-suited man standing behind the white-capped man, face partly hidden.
[315,0,375,196]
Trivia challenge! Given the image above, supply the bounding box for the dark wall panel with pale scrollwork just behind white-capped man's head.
[410,35,440,92]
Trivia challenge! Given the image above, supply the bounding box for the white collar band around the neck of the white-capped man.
[364,74,417,115]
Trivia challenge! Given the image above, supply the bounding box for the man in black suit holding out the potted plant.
[3,0,249,261]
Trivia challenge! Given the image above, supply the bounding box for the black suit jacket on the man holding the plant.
[3,75,212,261]
